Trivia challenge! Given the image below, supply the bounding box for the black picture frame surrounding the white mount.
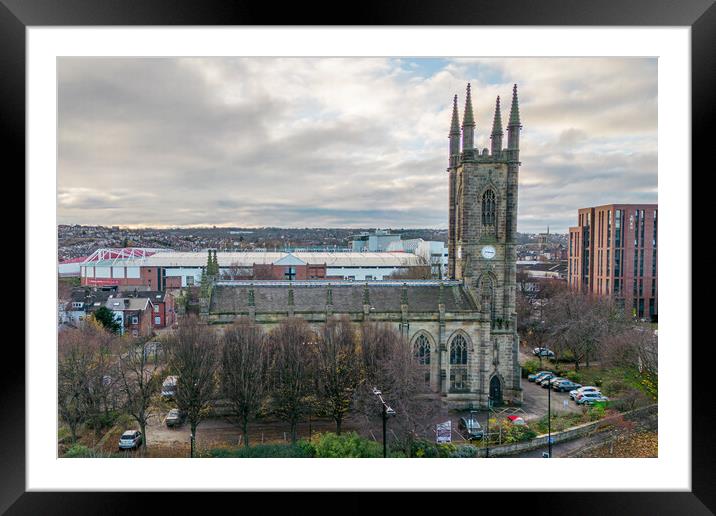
[0,0,716,515]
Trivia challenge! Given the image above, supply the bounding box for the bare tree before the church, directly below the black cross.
[268,318,316,443]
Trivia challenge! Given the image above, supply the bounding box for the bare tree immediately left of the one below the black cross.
[221,318,268,447]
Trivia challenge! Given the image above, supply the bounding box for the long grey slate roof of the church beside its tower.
[209,282,476,313]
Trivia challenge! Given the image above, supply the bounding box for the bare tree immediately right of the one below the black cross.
[313,317,361,435]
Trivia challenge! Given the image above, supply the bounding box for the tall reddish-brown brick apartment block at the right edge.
[567,204,659,320]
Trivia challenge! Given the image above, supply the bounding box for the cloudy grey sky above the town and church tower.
[58,58,657,232]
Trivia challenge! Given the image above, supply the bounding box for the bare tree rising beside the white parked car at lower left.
[119,337,159,450]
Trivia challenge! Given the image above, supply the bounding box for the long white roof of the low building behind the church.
[126,251,425,267]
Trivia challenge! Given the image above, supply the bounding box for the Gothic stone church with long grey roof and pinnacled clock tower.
[201,84,522,409]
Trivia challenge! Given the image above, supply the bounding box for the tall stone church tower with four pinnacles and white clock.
[447,84,522,408]
